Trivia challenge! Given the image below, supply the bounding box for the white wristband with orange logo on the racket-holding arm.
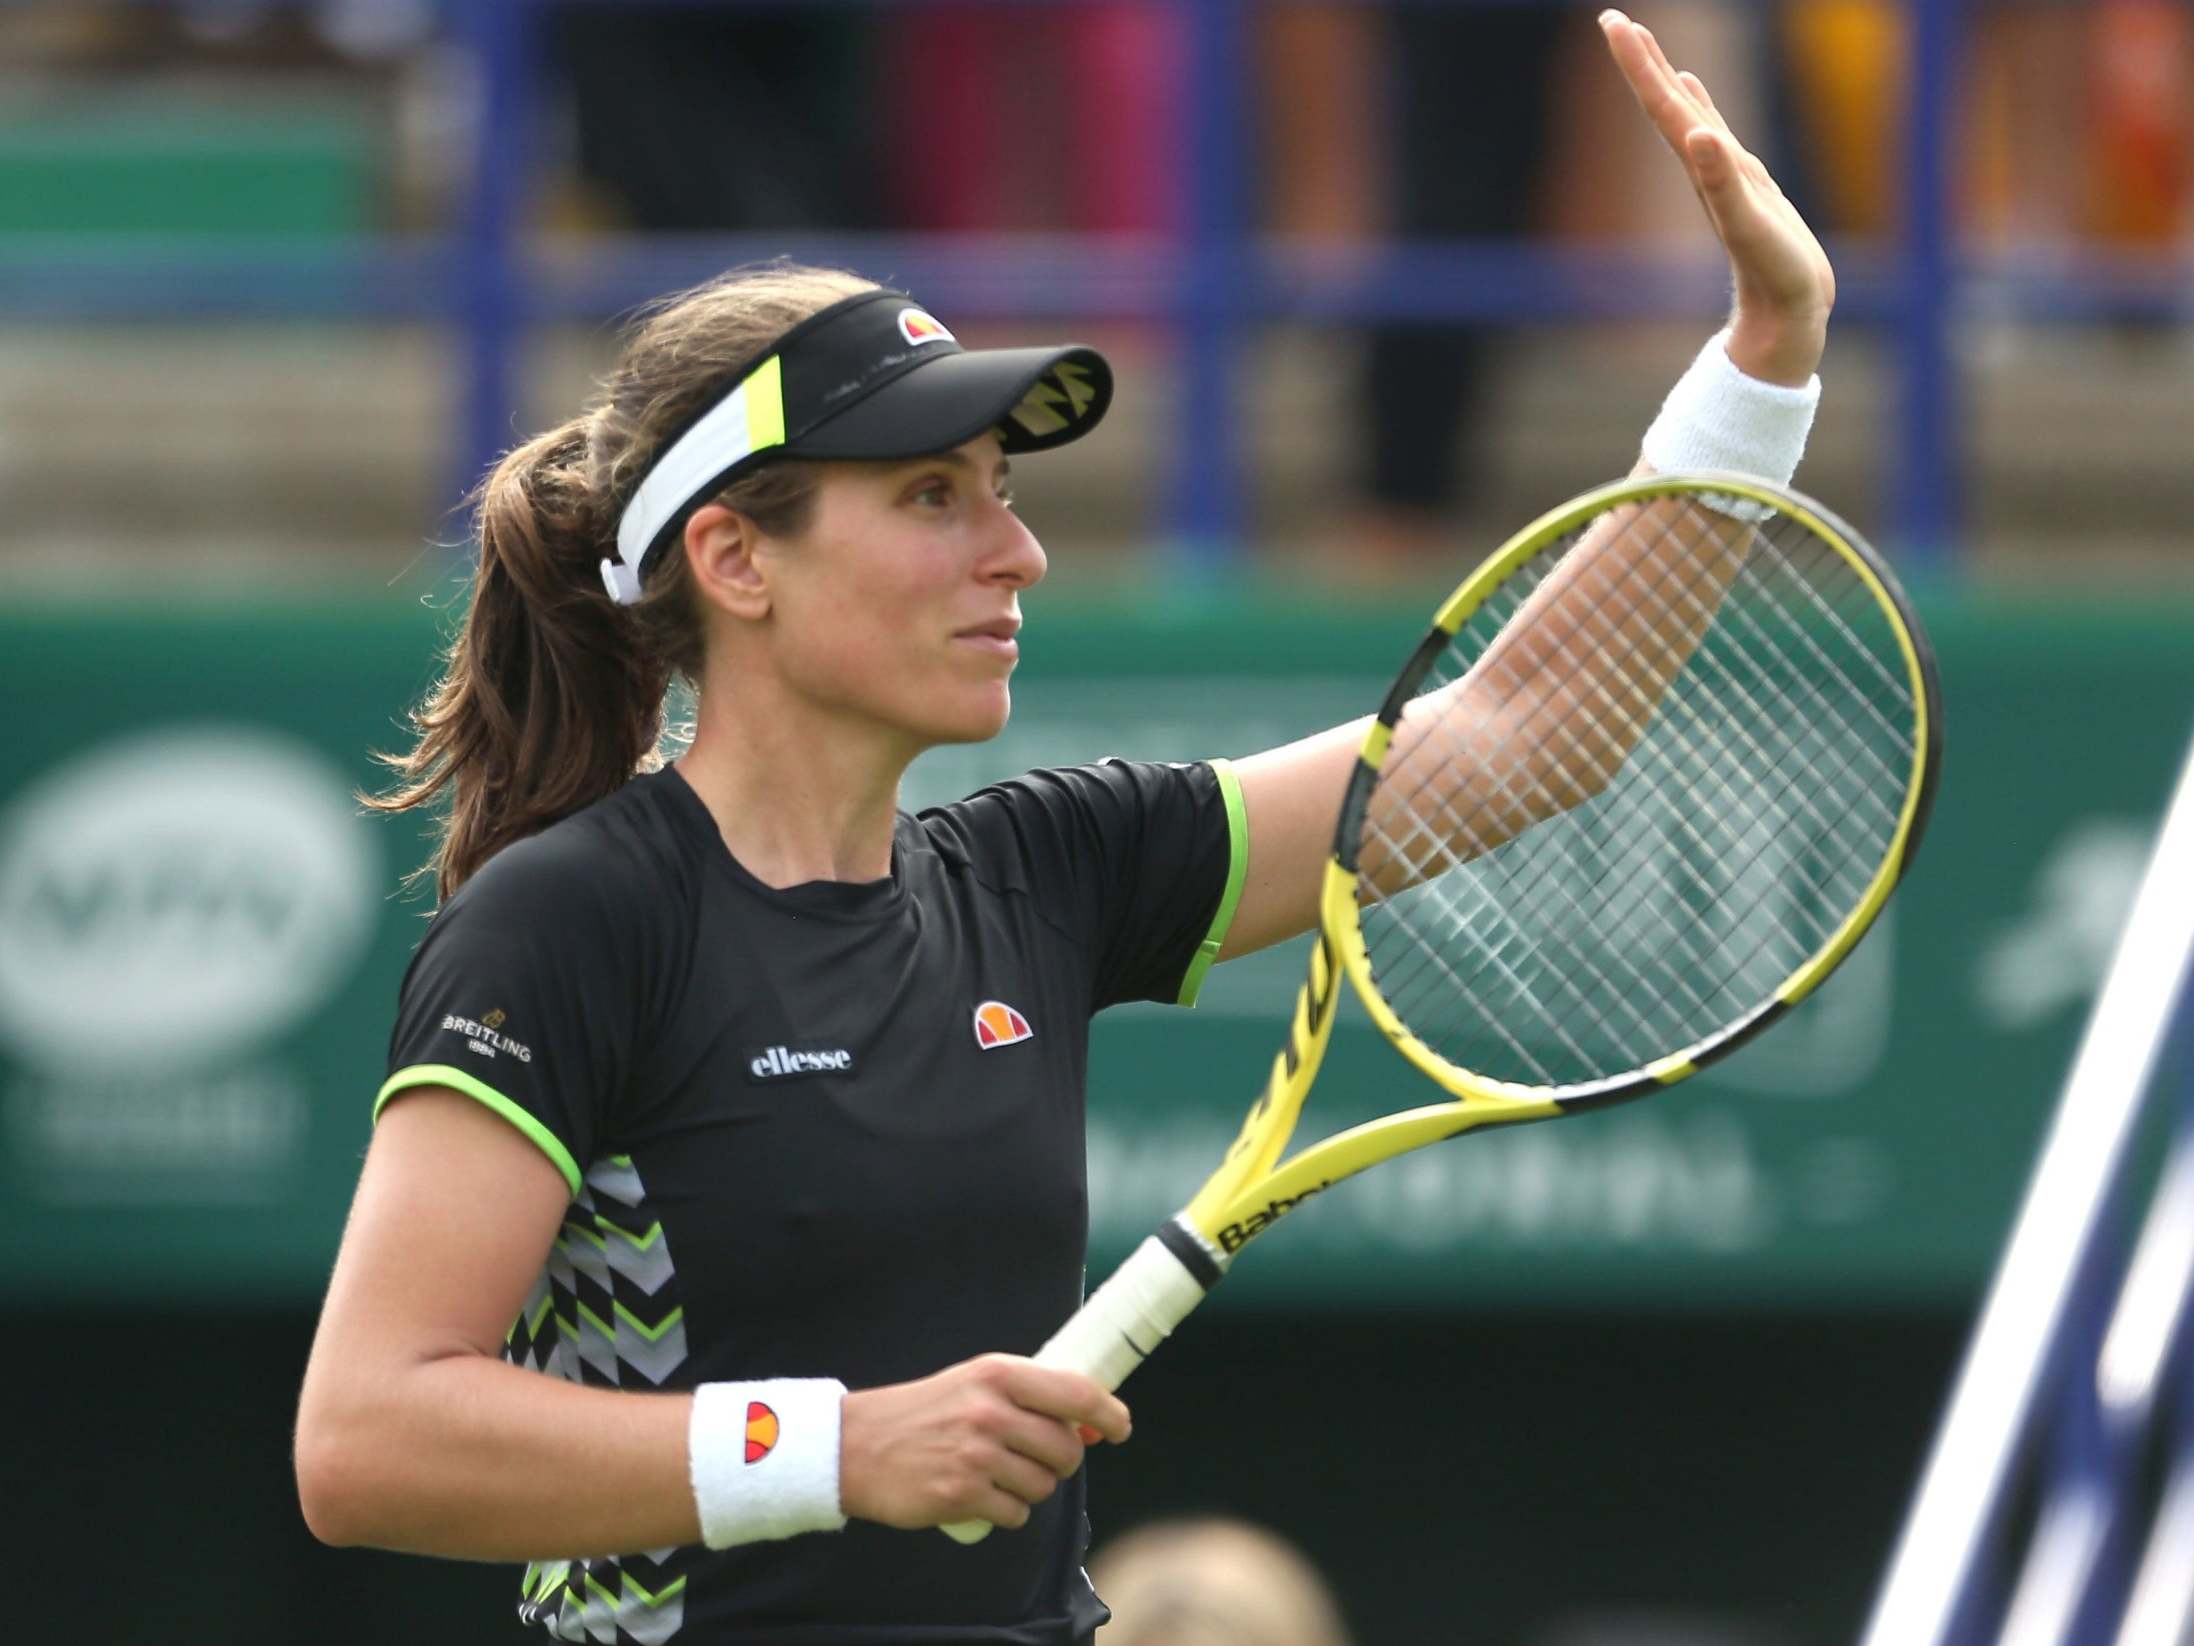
[687,1378,845,1549]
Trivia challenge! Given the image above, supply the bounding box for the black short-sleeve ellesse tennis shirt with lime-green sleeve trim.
[375,762,1246,1646]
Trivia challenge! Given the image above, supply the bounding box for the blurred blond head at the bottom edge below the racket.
[1088,1519,1349,1646]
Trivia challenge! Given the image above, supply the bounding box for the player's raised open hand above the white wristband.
[1599,11,1836,386]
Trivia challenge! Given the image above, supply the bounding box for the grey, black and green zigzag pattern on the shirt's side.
[502,1154,695,1646]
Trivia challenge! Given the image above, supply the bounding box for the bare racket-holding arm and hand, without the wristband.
[296,1086,1128,1560]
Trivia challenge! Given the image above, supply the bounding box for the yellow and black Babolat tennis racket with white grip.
[946,476,1942,1543]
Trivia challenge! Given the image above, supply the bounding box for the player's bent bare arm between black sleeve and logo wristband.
[296,1089,700,1560]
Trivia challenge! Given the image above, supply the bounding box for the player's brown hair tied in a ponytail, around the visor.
[366,263,871,898]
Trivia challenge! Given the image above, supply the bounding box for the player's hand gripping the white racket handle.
[838,1354,1128,1530]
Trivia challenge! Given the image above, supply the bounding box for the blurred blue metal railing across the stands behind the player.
[17,0,2194,571]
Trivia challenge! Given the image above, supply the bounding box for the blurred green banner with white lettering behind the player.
[0,595,2194,1308]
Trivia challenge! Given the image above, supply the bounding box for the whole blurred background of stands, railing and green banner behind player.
[0,0,2194,1646]
